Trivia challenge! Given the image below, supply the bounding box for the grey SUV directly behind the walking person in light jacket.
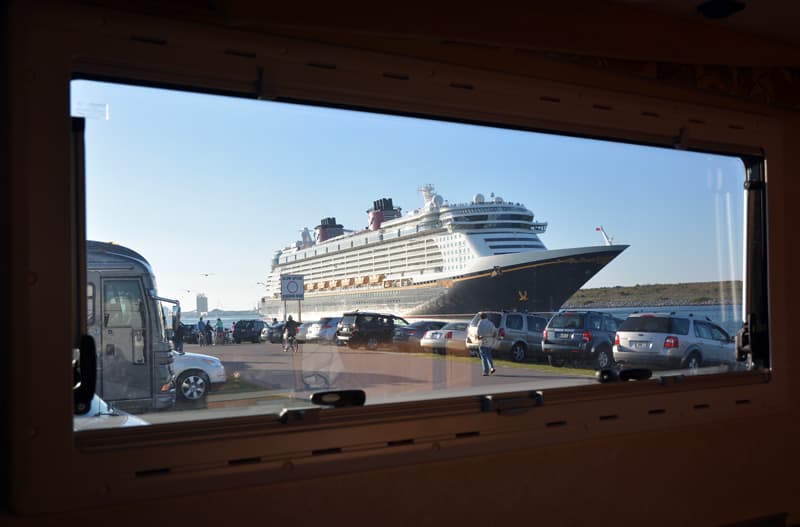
[466,311,547,362]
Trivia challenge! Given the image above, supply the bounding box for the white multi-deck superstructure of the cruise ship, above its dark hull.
[267,185,547,298]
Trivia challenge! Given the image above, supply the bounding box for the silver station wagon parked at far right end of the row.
[613,313,736,371]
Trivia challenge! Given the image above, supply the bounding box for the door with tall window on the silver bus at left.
[98,278,153,401]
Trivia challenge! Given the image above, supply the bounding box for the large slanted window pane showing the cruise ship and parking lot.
[71,81,746,432]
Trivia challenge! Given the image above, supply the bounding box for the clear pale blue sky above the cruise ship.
[71,80,744,310]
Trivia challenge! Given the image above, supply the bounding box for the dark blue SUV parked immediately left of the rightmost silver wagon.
[542,310,622,370]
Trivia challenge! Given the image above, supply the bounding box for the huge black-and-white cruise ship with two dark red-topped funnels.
[259,185,628,320]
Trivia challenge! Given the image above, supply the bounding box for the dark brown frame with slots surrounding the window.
[11,4,788,513]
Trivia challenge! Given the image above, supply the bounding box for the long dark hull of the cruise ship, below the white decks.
[261,245,627,320]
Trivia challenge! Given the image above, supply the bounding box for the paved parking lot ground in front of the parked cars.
[185,343,596,406]
